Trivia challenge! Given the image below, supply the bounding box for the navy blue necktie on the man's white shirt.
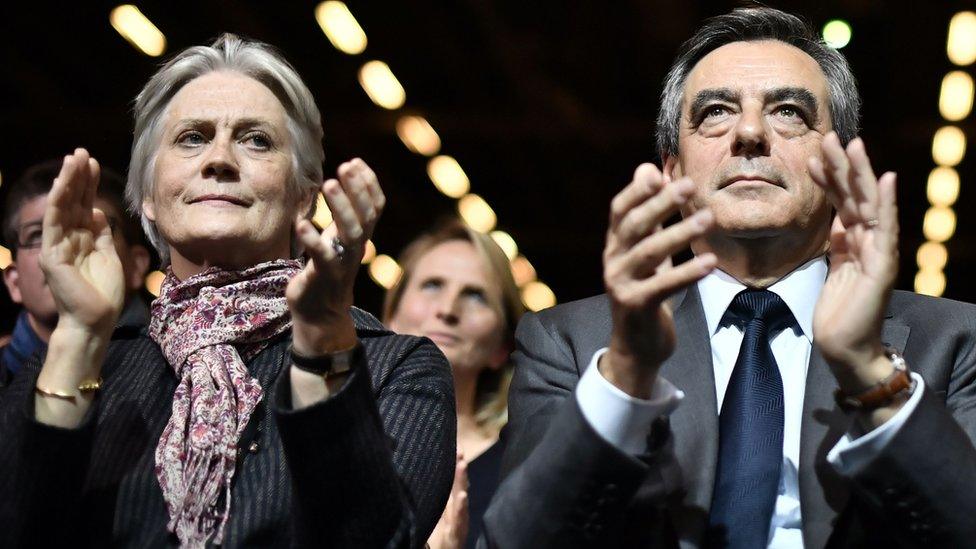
[709,290,795,549]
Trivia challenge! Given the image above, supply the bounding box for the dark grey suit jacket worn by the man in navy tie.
[483,286,976,549]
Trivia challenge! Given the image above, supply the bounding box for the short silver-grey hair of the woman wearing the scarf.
[125,33,325,265]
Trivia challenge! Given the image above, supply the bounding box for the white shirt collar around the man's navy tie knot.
[698,255,828,342]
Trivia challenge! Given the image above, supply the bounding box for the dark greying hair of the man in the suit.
[656,6,861,157]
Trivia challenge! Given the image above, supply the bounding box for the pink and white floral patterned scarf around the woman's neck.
[149,259,302,547]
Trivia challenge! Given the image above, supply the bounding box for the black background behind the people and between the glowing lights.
[0,0,976,329]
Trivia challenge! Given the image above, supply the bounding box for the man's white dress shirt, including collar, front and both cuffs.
[576,256,924,548]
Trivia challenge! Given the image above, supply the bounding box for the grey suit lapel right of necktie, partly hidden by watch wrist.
[799,314,910,548]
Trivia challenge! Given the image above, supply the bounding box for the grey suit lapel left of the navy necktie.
[661,285,718,539]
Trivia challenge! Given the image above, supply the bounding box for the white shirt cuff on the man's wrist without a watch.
[576,347,685,456]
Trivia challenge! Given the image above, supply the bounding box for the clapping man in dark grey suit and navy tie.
[484,8,976,548]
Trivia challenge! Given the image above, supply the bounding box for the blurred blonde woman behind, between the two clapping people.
[383,221,523,549]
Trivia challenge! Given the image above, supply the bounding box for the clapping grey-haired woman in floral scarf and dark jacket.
[0,35,455,547]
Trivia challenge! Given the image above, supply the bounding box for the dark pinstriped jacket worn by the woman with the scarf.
[0,310,456,547]
